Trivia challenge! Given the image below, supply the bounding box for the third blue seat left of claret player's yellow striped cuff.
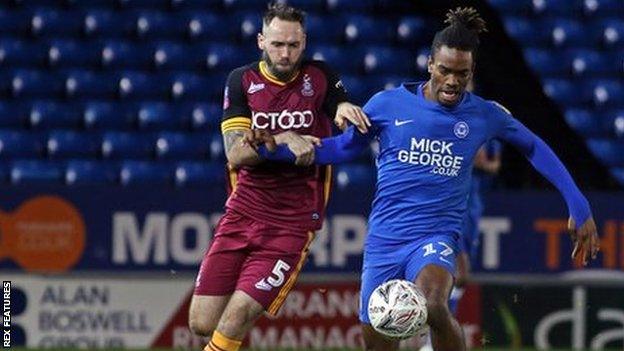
[82,102,136,130]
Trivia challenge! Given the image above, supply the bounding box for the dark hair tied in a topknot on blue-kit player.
[431,7,487,59]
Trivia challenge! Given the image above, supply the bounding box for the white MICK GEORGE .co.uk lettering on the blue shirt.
[398,138,464,177]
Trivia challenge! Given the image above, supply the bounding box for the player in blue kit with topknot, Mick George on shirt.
[252,8,599,351]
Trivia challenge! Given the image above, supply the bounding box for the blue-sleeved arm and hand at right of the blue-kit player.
[504,121,600,264]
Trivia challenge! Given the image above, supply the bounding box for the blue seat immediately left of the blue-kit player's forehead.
[364,46,414,74]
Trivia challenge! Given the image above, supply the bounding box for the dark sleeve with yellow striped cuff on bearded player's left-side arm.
[221,67,251,134]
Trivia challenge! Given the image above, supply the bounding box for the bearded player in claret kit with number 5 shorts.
[189,4,367,351]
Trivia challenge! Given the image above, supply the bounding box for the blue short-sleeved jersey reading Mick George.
[364,82,521,241]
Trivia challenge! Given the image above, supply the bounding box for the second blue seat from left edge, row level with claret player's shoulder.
[65,70,119,99]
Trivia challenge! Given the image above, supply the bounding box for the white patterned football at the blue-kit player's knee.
[368,279,427,339]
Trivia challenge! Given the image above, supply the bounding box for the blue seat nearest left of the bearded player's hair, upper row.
[182,11,232,41]
